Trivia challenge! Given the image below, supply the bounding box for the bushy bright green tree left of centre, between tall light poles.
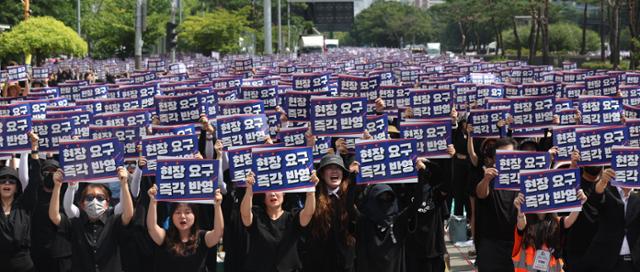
[178,9,252,54]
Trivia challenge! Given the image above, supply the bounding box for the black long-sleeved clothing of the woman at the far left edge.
[0,156,42,272]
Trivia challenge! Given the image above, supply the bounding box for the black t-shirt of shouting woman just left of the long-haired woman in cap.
[245,206,303,272]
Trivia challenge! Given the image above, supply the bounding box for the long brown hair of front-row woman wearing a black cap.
[311,171,356,246]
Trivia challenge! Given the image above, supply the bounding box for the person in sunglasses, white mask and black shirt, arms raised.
[49,167,134,272]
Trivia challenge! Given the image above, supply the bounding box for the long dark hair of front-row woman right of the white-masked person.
[164,203,201,256]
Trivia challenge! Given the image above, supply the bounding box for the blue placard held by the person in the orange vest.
[520,168,582,213]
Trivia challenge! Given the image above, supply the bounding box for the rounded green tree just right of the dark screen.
[351,2,431,47]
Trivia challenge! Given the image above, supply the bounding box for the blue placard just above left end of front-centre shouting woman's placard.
[216,114,269,148]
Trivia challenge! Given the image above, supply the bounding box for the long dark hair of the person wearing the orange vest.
[523,213,561,249]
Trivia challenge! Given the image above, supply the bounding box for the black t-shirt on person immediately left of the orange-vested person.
[474,170,518,242]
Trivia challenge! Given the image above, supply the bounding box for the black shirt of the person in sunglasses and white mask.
[58,209,123,272]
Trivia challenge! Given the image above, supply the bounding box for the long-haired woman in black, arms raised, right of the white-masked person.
[147,185,224,272]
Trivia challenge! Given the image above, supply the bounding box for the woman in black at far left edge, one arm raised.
[0,132,41,272]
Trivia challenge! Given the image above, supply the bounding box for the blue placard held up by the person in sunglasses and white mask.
[58,138,124,183]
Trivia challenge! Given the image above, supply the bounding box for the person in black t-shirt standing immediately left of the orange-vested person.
[475,138,518,271]
